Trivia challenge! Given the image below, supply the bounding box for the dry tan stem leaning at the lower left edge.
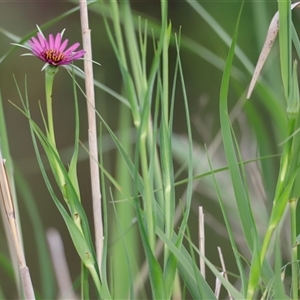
[0,151,35,299]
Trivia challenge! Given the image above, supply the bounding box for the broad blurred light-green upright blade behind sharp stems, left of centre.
[110,105,136,299]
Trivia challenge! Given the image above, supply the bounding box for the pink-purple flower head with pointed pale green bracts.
[13,26,85,70]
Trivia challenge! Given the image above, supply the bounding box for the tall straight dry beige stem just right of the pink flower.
[79,0,104,272]
